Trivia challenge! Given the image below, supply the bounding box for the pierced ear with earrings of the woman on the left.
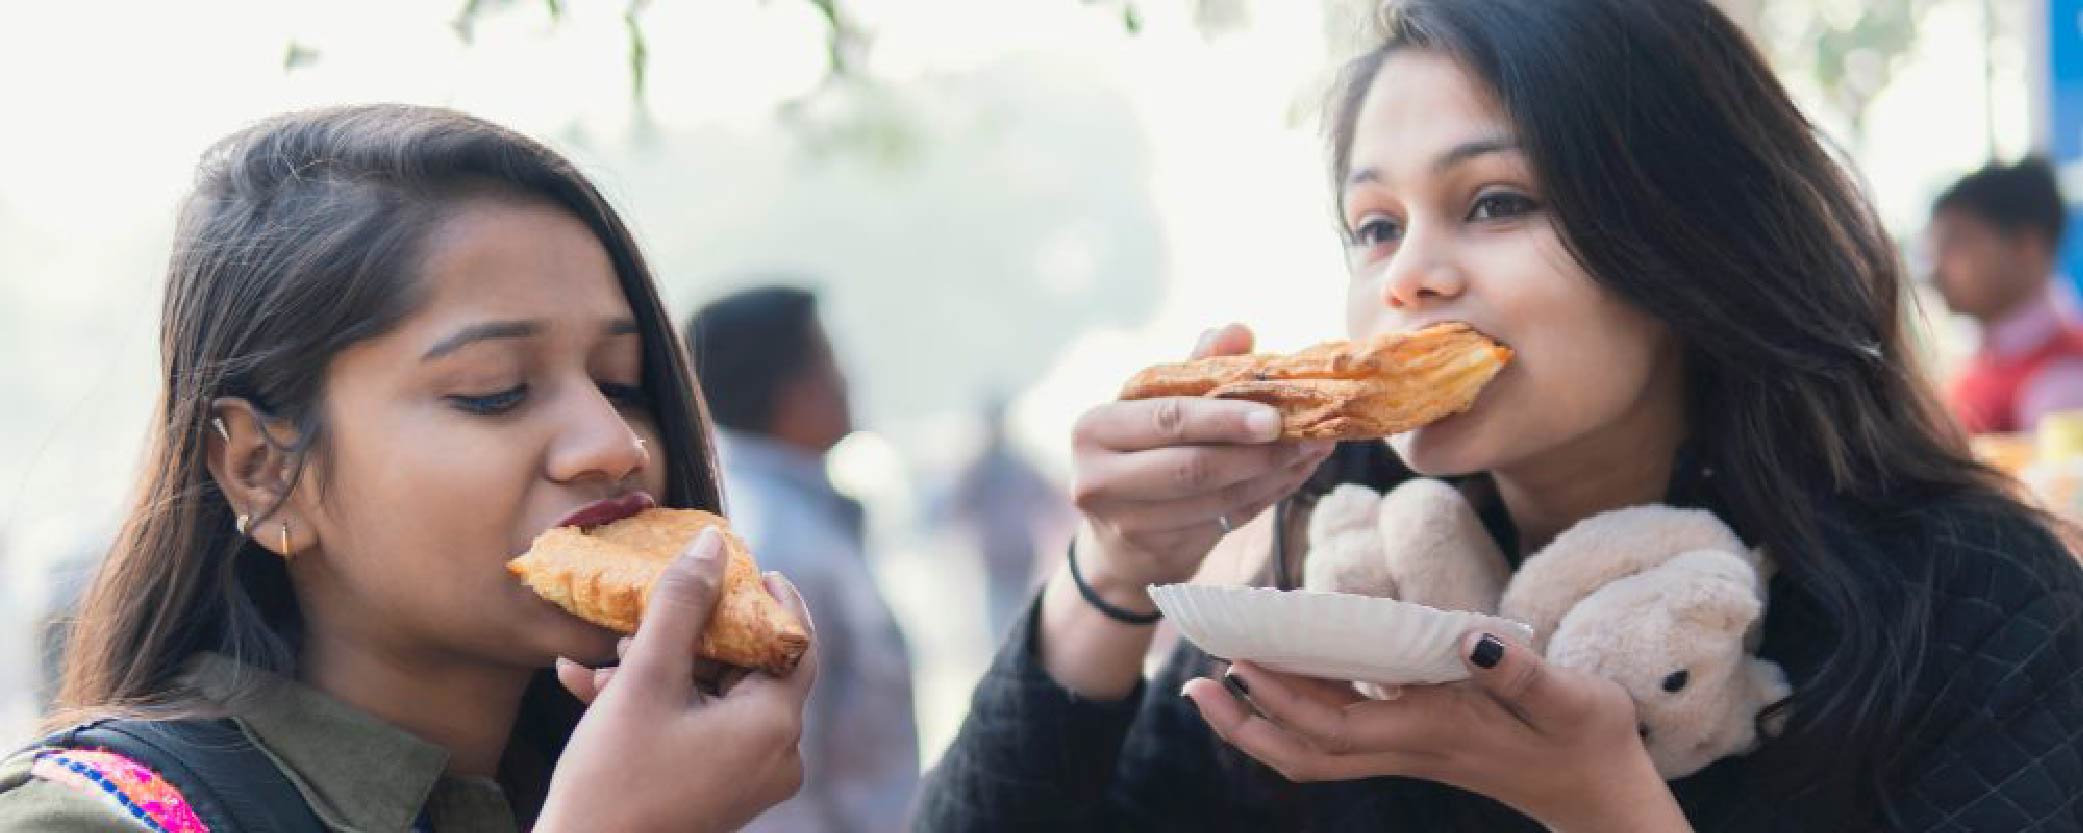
[204,396,317,556]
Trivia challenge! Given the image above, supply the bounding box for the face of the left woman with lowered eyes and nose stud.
[289,198,667,666]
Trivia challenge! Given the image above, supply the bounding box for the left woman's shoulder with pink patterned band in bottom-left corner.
[0,748,208,833]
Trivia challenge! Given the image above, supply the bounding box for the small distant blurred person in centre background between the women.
[929,394,1073,637]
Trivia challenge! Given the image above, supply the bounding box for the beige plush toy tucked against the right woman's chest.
[1304,479,1789,779]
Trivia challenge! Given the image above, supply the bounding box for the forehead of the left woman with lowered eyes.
[419,198,629,323]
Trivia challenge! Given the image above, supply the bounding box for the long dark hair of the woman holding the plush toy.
[1327,0,2031,825]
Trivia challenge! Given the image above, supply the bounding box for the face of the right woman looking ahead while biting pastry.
[1341,50,1679,475]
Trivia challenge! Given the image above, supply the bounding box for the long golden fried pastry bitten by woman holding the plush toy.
[1121,323,1512,441]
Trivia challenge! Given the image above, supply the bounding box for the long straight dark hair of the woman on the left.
[54,104,721,808]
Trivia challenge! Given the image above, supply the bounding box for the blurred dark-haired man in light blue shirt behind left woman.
[687,285,919,833]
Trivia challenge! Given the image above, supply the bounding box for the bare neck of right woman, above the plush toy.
[1491,379,1685,556]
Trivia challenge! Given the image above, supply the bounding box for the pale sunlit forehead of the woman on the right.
[1352,50,1512,181]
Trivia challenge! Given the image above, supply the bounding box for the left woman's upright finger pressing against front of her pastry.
[617,529,729,696]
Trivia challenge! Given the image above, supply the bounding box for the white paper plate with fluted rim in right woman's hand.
[1150,585,1533,685]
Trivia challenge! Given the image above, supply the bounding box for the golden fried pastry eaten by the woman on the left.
[506,508,810,675]
